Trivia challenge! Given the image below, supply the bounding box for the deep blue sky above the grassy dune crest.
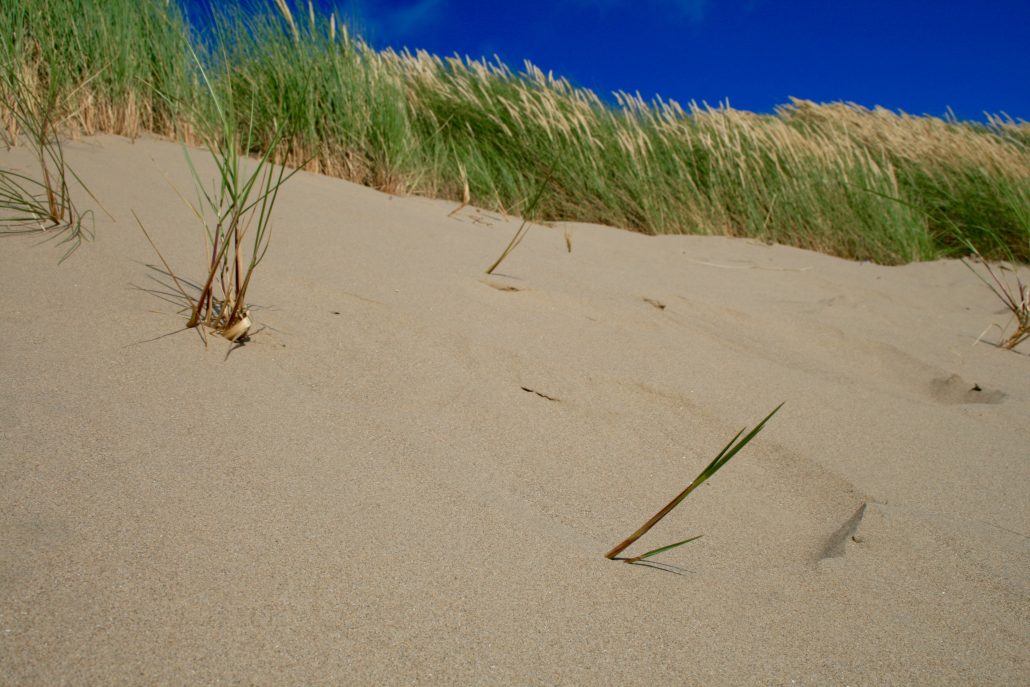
[181,0,1030,119]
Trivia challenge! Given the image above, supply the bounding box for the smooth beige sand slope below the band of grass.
[0,137,1030,685]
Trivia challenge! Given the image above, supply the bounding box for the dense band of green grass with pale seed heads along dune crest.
[0,0,1030,264]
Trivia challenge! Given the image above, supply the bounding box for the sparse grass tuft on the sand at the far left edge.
[0,65,94,262]
